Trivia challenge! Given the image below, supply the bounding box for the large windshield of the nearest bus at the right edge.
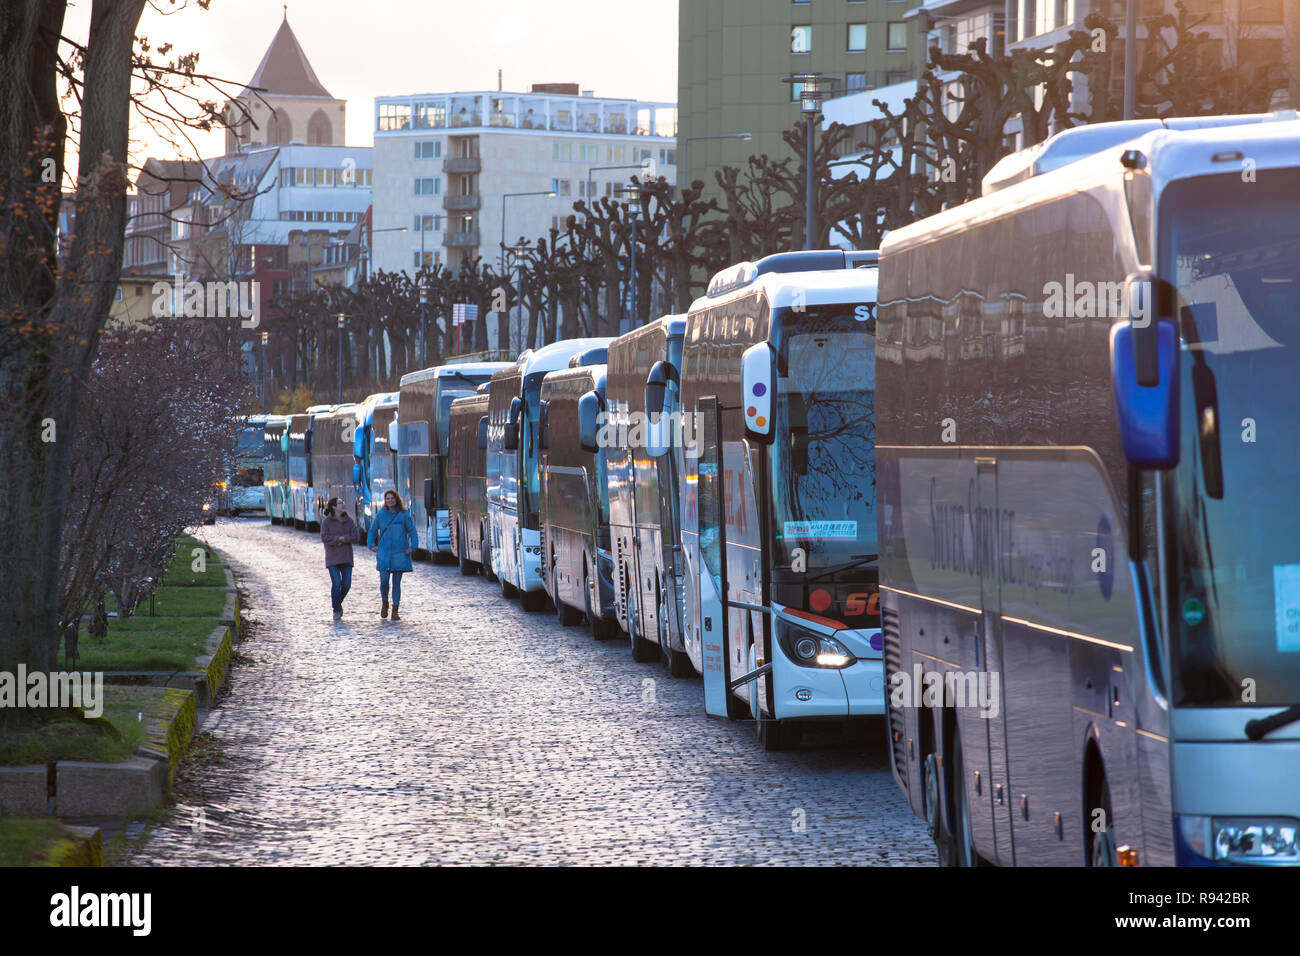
[1160,170,1300,706]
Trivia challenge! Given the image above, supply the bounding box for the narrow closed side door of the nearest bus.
[965,458,1015,866]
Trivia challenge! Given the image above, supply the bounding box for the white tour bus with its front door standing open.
[663,251,884,749]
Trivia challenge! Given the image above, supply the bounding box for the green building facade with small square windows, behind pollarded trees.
[677,0,924,195]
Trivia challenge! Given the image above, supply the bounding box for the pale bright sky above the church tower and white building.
[64,0,677,164]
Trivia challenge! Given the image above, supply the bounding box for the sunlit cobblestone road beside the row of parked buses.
[122,519,935,865]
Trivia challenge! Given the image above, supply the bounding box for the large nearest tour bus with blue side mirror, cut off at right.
[876,114,1300,866]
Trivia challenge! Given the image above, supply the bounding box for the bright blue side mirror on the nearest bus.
[1110,321,1179,470]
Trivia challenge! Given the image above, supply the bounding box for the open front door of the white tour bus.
[696,395,731,717]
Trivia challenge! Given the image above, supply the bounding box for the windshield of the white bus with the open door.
[771,306,876,570]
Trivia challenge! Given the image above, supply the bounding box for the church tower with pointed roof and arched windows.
[226,10,347,153]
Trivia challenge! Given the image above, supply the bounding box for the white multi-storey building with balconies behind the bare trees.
[374,83,677,274]
